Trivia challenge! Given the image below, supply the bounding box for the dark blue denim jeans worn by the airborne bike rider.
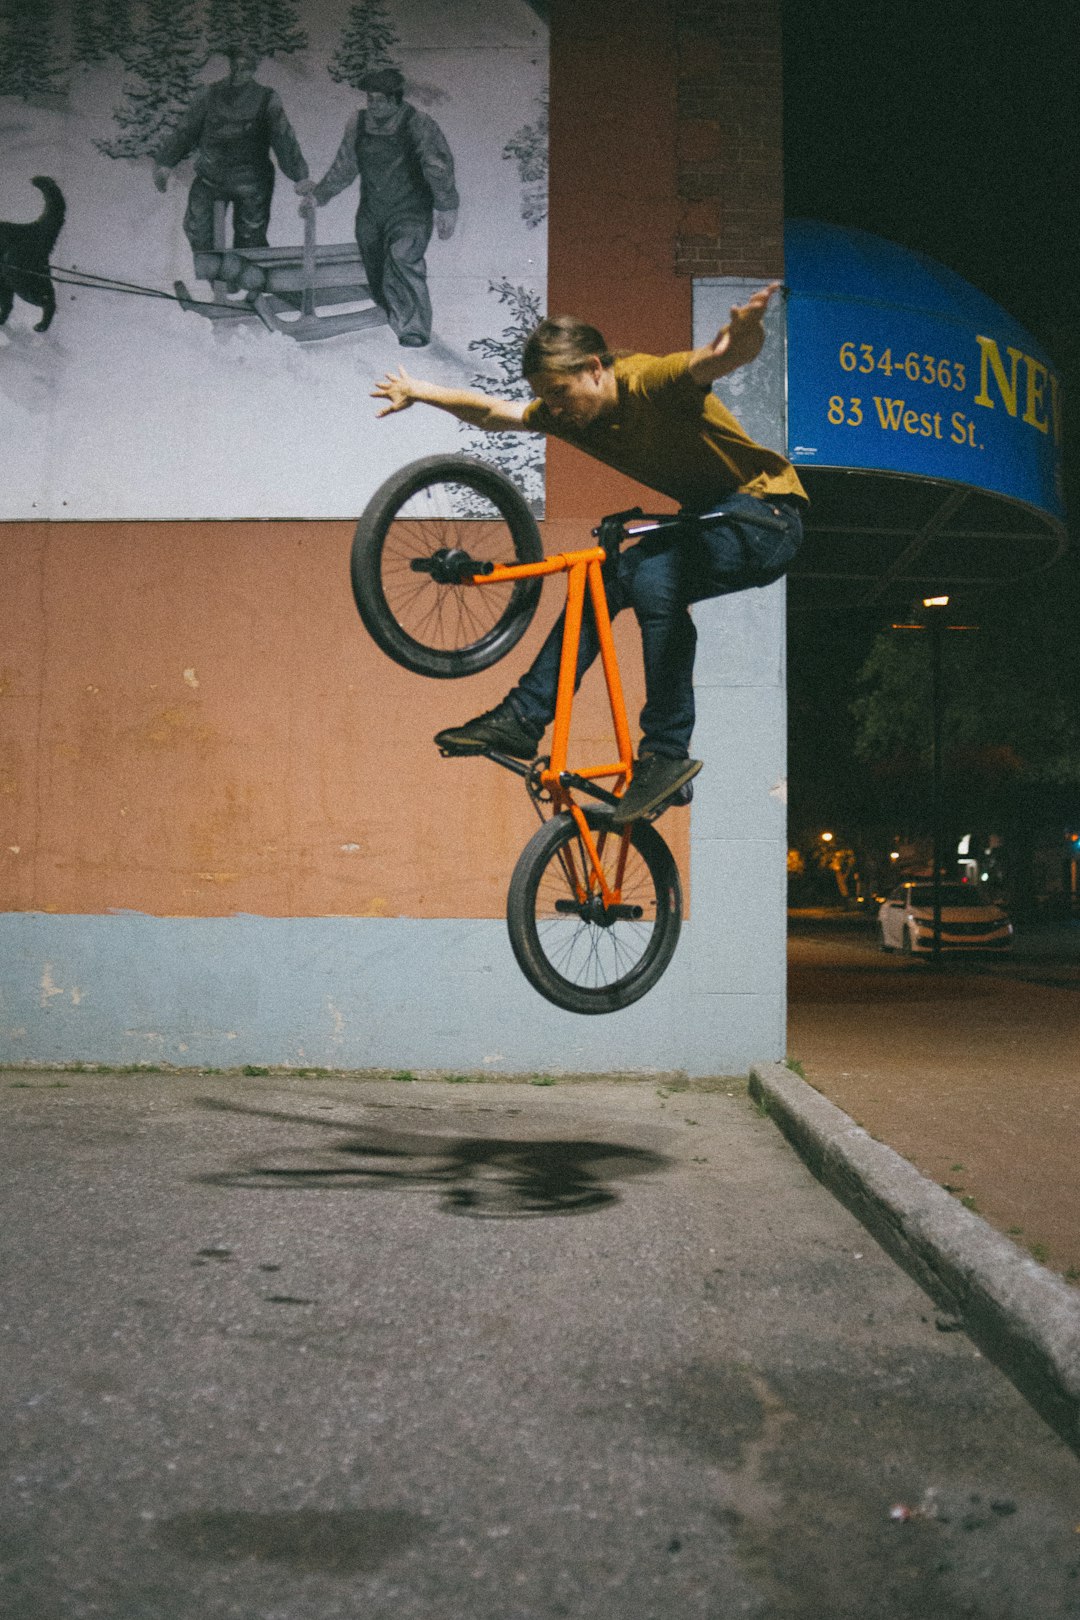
[508,494,805,760]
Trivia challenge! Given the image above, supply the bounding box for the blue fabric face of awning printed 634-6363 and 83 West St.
[784,219,1064,518]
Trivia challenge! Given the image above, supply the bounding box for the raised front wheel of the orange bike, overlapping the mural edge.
[351,455,544,680]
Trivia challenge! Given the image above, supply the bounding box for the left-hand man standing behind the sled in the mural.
[154,45,308,279]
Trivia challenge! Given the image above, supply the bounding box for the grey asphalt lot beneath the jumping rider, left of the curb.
[0,1071,1080,1620]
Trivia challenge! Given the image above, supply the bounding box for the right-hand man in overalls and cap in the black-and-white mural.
[300,68,458,348]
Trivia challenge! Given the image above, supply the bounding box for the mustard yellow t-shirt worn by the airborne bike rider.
[525,350,806,512]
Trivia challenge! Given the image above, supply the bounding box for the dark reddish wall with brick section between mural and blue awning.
[547,0,784,518]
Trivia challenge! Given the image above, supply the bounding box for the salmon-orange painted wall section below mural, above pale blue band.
[0,523,683,917]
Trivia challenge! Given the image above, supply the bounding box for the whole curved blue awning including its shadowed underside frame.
[785,219,1065,611]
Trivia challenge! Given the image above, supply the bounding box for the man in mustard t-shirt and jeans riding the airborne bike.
[372,282,806,825]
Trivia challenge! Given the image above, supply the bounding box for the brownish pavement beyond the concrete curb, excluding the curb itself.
[787,919,1080,1276]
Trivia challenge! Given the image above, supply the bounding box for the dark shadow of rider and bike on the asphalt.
[194,1097,670,1220]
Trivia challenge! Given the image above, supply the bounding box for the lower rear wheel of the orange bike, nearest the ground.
[507,810,682,1013]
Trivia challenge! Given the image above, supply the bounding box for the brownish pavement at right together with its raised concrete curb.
[780,915,1080,1450]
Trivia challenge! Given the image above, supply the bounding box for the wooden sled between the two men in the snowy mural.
[175,203,387,343]
